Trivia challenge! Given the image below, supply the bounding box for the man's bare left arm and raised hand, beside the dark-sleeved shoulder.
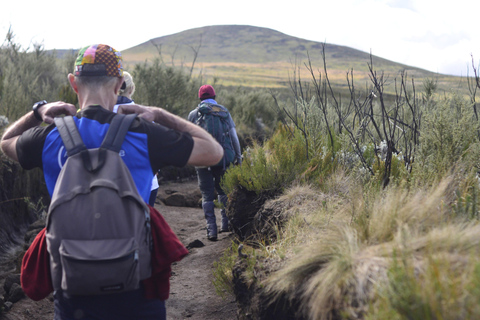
[0,101,77,161]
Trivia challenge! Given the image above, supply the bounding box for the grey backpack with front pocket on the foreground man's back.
[46,114,152,295]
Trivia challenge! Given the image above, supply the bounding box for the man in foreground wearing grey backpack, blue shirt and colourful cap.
[0,44,223,320]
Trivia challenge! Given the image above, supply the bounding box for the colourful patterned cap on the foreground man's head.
[74,44,123,77]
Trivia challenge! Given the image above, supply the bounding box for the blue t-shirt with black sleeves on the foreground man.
[17,106,193,203]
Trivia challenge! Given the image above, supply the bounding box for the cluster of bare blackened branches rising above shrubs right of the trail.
[272,44,424,188]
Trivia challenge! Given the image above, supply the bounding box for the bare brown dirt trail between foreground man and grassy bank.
[156,183,237,320]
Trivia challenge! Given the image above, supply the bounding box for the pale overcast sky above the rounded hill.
[0,0,480,76]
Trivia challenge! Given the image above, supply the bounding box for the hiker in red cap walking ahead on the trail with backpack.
[188,84,242,241]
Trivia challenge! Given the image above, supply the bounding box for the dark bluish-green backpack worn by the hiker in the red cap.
[196,102,235,169]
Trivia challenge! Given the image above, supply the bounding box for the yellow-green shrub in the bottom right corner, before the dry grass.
[365,246,480,320]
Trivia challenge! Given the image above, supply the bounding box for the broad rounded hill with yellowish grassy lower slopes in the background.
[122,25,464,90]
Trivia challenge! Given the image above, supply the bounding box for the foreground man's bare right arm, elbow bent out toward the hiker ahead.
[118,105,223,166]
